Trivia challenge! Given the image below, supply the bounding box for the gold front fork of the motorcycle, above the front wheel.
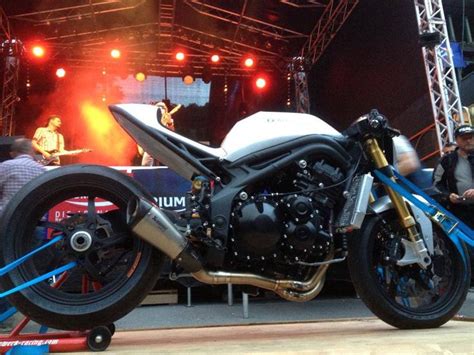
[365,138,431,268]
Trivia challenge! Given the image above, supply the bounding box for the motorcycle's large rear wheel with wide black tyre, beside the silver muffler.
[0,165,164,330]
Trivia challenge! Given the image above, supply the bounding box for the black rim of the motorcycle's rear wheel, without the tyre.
[14,186,143,306]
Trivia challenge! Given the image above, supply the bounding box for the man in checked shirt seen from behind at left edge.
[0,138,46,332]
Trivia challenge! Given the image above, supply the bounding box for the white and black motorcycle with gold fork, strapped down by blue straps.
[0,104,470,330]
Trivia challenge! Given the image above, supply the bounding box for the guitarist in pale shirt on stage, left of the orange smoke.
[32,115,67,165]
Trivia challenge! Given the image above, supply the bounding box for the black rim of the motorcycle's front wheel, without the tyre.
[370,222,463,315]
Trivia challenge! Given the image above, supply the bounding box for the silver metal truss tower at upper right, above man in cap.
[415,0,464,152]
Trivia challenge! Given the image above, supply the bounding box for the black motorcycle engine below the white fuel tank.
[230,160,344,271]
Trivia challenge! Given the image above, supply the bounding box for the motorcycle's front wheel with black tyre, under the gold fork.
[348,212,470,329]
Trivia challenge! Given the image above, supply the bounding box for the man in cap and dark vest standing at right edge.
[433,125,474,228]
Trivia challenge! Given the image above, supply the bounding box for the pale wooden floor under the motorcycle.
[67,319,474,355]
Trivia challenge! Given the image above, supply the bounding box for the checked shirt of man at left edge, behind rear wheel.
[0,154,46,215]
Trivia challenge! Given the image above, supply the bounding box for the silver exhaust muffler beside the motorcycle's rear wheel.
[127,198,202,273]
